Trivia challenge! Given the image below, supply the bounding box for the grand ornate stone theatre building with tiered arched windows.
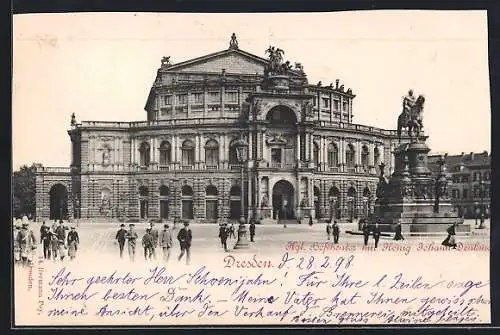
[37,36,408,222]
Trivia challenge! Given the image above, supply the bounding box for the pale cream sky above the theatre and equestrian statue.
[12,11,491,169]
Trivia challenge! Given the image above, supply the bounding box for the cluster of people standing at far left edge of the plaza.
[13,219,80,266]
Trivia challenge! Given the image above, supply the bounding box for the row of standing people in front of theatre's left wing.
[115,222,193,264]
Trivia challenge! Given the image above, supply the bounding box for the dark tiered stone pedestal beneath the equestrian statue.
[368,137,471,235]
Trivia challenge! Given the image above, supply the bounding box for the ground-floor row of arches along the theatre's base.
[37,179,375,222]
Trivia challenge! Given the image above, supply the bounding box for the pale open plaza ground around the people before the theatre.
[17,220,489,264]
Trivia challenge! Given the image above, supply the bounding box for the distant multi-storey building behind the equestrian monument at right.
[429,151,491,219]
